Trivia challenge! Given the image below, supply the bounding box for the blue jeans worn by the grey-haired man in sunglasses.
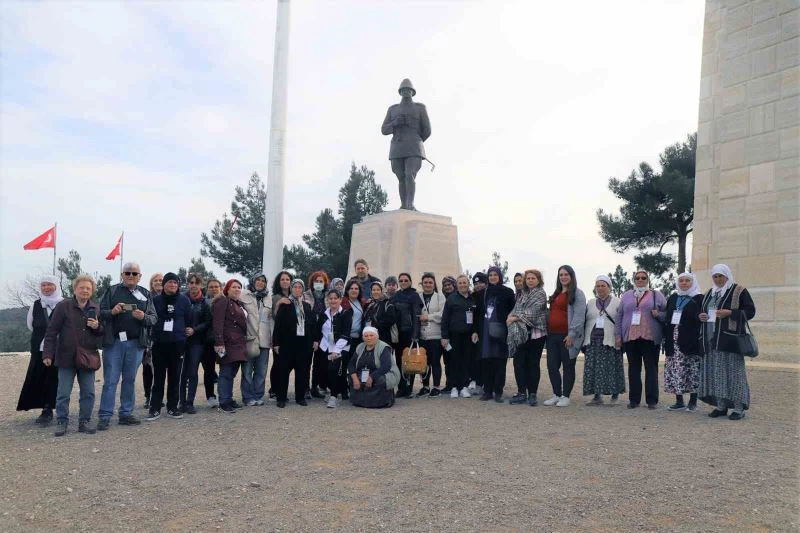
[97,339,144,418]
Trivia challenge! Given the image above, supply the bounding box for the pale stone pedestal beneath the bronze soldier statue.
[347,209,461,287]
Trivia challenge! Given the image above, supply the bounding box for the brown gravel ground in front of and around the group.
[0,355,800,531]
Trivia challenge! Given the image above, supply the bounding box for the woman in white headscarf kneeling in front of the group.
[347,326,400,407]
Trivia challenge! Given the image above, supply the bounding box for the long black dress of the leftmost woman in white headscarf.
[17,300,58,411]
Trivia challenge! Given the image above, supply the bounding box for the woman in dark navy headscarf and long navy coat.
[476,266,515,403]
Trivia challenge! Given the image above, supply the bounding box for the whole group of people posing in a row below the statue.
[17,259,755,436]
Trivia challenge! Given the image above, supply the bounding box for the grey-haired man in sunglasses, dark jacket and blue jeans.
[97,262,158,431]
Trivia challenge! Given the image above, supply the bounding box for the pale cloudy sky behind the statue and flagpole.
[0,0,704,302]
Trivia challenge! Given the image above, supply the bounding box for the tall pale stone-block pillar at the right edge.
[692,0,800,363]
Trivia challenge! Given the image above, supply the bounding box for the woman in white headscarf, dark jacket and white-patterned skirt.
[664,272,703,411]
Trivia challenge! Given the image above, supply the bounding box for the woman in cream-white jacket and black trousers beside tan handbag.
[411,272,447,397]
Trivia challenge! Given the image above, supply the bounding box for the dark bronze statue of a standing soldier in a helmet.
[381,78,431,211]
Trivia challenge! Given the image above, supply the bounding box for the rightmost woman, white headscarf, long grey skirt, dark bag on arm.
[699,264,756,420]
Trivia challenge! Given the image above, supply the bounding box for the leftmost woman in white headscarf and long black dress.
[17,276,64,424]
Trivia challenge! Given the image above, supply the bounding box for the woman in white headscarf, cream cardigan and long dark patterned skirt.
[583,276,625,406]
